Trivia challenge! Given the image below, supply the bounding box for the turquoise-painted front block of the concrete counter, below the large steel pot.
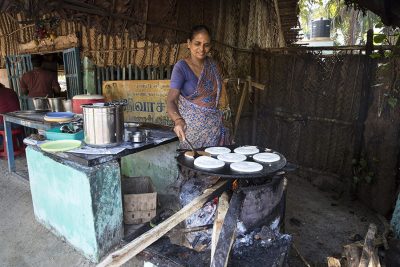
[26,146,123,262]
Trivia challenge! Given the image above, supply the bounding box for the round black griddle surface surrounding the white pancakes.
[176,146,286,179]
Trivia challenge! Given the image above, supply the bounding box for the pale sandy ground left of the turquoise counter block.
[0,158,92,267]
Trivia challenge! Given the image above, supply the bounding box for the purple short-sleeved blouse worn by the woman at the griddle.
[170,59,199,97]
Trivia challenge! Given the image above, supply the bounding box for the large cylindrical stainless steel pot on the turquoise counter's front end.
[82,105,124,147]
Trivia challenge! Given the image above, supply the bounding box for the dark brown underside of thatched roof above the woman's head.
[0,0,298,43]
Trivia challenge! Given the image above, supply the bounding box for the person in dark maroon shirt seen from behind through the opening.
[20,55,61,109]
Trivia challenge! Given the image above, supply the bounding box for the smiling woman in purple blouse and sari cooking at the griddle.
[167,25,228,148]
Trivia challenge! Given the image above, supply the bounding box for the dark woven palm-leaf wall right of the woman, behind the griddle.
[237,49,371,177]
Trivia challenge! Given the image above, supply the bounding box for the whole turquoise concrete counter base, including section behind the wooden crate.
[26,140,178,262]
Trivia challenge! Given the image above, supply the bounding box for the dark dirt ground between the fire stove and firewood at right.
[285,174,382,266]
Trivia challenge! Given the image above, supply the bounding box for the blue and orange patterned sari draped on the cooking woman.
[178,58,228,149]
